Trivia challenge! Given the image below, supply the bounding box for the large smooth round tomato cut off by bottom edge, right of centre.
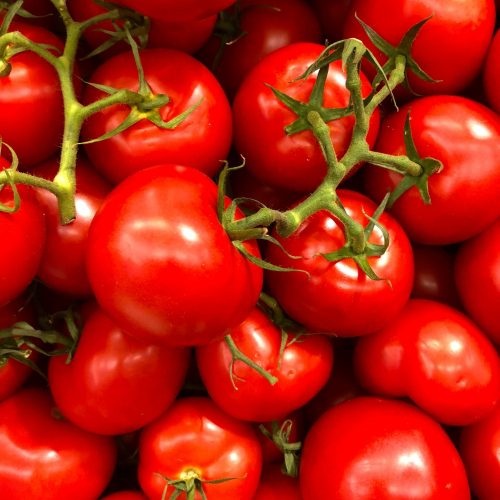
[299,397,470,500]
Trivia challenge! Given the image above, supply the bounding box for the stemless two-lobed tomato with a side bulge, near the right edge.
[354,299,500,425]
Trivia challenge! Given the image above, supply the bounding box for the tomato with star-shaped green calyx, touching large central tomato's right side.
[266,189,413,337]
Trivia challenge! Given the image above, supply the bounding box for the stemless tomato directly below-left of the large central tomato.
[49,309,190,435]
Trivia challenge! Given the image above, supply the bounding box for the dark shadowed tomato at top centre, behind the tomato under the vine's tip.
[198,0,321,98]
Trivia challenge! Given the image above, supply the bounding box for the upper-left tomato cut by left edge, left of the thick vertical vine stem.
[0,22,64,168]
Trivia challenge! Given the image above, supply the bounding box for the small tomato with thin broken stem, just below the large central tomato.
[196,308,333,422]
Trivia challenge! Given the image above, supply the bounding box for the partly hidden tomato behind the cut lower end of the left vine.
[31,158,111,297]
